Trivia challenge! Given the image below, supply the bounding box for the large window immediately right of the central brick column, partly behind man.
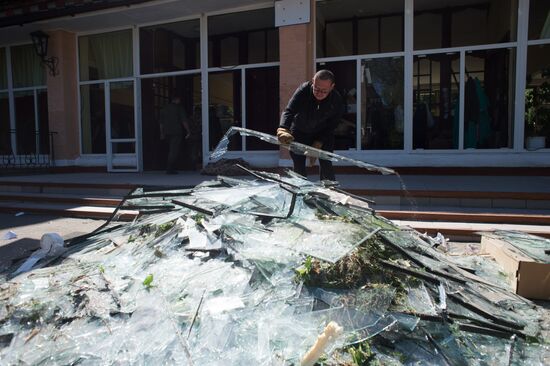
[316,0,405,150]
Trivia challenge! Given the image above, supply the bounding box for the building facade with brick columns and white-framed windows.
[0,0,550,171]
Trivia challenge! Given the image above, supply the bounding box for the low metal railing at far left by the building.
[0,130,57,170]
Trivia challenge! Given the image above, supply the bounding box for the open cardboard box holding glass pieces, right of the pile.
[479,232,550,300]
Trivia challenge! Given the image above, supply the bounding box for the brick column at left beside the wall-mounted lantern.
[47,30,80,165]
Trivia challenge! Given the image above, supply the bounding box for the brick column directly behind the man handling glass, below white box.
[279,1,315,166]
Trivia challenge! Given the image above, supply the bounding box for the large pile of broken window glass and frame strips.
[0,128,549,365]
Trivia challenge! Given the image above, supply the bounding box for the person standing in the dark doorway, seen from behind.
[160,96,190,174]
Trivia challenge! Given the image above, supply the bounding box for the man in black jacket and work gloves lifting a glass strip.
[277,70,344,180]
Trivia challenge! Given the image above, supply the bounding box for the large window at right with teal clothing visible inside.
[413,0,518,149]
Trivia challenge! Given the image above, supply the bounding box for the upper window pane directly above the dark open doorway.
[139,19,200,74]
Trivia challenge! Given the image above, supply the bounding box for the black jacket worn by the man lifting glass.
[279,81,344,136]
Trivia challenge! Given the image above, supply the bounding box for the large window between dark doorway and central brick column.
[208,8,279,151]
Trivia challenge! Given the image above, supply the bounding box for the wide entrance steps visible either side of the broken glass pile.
[0,176,550,237]
